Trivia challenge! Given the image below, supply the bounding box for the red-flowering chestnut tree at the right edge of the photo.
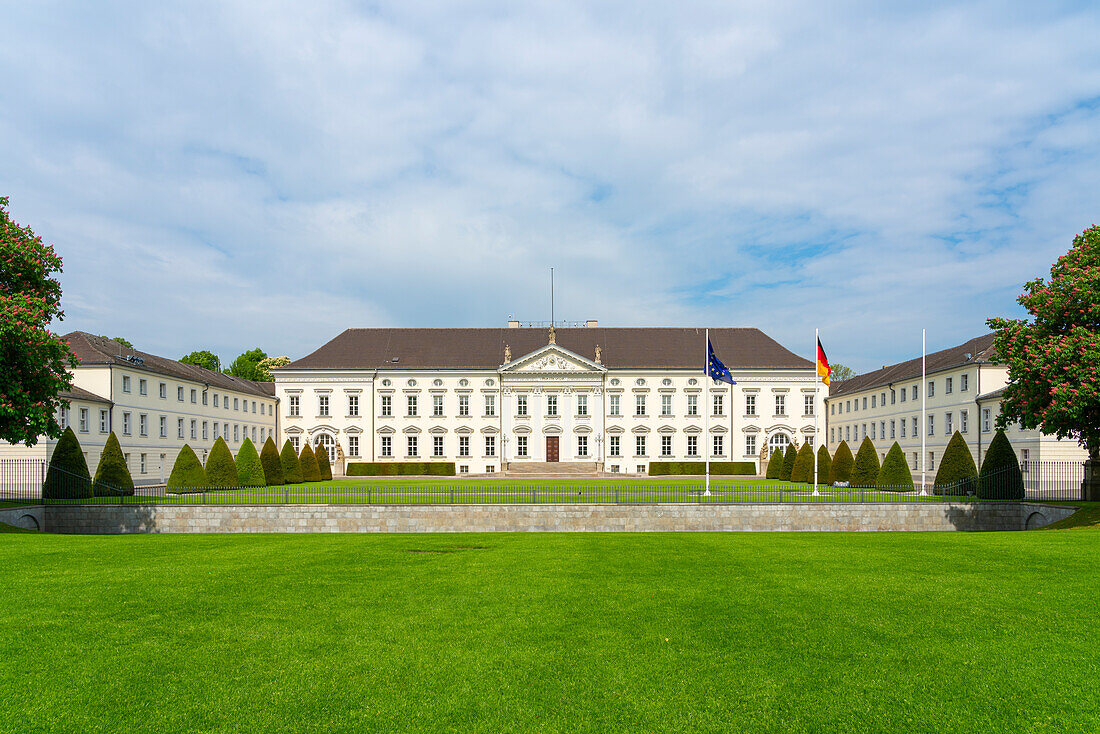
[982,224,1100,500]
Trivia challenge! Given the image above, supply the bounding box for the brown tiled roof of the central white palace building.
[285,327,813,371]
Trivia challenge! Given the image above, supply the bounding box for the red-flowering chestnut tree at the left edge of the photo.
[0,197,77,446]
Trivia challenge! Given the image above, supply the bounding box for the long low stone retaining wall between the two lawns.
[45,502,1076,533]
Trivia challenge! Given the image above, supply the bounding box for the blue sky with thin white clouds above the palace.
[0,0,1100,372]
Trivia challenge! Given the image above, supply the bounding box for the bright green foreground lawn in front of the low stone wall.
[0,519,1100,732]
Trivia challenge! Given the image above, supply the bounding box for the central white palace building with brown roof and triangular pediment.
[274,321,824,474]
